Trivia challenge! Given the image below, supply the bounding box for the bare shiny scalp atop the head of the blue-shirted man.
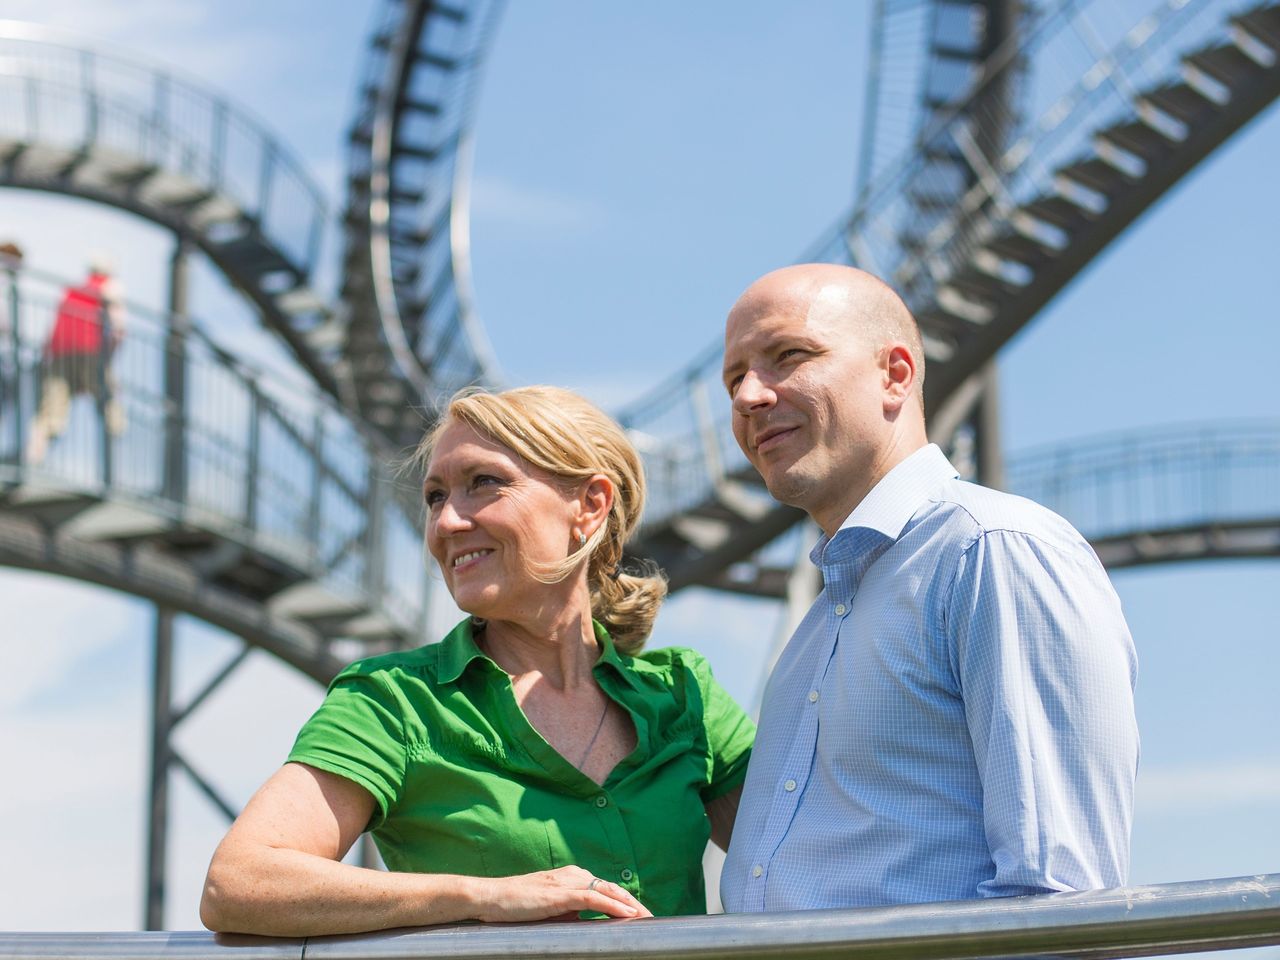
[730,264,924,399]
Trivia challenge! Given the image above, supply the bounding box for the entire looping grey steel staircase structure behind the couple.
[0,0,1280,927]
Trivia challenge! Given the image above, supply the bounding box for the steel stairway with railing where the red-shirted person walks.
[0,271,426,682]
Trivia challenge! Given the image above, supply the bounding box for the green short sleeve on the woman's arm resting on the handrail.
[289,664,406,829]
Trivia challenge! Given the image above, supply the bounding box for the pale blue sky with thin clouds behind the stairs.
[0,0,1280,929]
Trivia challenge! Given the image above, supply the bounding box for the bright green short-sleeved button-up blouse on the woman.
[289,621,755,916]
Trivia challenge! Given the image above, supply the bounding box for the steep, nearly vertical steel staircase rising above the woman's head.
[342,0,502,445]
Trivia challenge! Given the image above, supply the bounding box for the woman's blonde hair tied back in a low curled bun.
[415,387,667,653]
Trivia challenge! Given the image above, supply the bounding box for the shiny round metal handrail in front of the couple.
[0,874,1280,960]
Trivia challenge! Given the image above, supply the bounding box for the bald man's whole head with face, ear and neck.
[723,264,928,535]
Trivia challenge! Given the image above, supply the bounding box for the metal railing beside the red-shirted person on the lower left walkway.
[0,263,426,640]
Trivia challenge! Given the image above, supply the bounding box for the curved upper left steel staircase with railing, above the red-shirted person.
[0,20,351,407]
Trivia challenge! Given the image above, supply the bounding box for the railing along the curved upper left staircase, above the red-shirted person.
[0,20,328,276]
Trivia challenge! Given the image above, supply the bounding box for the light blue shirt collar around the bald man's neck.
[809,443,960,566]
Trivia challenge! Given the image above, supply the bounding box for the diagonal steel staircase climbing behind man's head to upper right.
[622,0,1280,596]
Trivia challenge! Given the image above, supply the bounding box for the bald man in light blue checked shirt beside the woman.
[721,264,1138,913]
